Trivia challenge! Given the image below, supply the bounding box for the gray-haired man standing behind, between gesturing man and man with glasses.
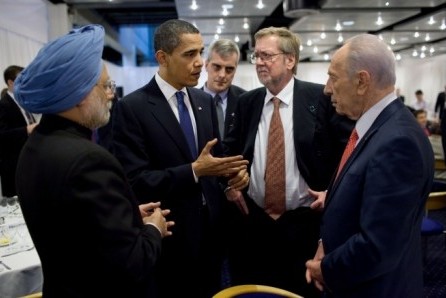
[202,39,246,139]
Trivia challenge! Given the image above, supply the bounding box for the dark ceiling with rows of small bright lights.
[50,0,446,62]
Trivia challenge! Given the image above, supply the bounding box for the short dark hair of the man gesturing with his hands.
[154,20,200,54]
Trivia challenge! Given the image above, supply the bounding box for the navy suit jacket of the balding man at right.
[321,100,434,298]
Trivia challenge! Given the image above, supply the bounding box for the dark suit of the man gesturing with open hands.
[113,78,225,296]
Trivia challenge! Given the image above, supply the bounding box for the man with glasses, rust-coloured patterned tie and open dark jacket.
[224,27,353,297]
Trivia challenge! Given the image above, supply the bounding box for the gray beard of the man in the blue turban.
[80,92,112,129]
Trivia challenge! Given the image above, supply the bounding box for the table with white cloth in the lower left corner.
[0,203,43,298]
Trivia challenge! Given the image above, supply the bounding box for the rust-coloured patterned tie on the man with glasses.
[265,97,285,219]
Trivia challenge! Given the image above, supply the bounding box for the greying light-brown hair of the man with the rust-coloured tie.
[254,27,300,74]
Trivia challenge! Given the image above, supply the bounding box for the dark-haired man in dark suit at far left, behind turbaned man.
[0,65,38,204]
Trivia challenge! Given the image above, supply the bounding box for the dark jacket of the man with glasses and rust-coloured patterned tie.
[224,79,353,190]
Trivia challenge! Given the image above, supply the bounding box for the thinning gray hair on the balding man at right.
[345,34,396,88]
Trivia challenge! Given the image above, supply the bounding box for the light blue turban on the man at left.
[14,25,104,114]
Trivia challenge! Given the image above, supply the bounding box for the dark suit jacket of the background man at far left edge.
[0,93,28,197]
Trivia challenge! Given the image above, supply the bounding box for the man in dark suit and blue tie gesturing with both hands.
[113,20,249,298]
